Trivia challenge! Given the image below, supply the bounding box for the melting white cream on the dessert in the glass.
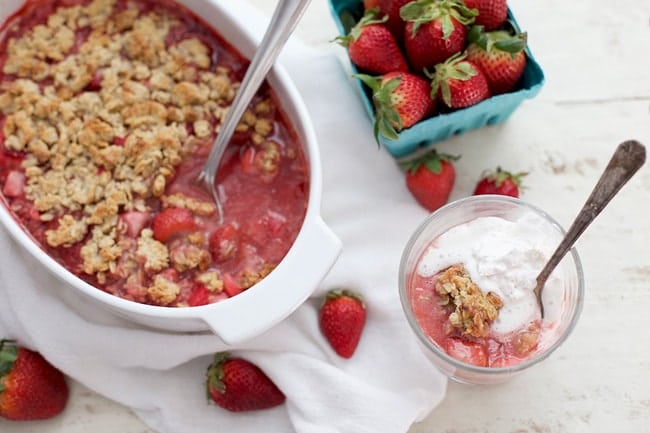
[417,213,562,336]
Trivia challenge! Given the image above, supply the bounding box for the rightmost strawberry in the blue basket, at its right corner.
[466,26,526,95]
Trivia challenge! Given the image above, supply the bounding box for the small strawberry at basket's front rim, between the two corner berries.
[428,55,490,108]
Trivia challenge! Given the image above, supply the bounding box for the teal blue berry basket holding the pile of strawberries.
[329,0,544,158]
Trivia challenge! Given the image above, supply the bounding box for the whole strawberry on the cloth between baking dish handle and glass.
[319,290,366,358]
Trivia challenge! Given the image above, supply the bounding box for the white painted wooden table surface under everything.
[0,0,650,433]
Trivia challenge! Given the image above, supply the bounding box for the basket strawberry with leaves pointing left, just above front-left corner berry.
[336,9,409,74]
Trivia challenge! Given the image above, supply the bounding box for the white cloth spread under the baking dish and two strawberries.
[0,1,446,433]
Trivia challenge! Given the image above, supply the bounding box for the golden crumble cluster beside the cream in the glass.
[434,265,503,338]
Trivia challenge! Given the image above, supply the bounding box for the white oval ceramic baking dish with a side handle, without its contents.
[0,0,341,344]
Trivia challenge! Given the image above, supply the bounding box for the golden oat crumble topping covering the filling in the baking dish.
[0,0,292,305]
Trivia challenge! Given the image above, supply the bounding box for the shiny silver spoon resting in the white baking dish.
[197,0,310,223]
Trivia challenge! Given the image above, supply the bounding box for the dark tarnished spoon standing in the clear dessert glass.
[534,140,645,318]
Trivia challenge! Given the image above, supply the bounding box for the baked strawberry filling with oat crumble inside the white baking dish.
[0,0,309,307]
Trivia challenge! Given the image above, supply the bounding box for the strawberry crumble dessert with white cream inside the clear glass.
[408,215,563,367]
